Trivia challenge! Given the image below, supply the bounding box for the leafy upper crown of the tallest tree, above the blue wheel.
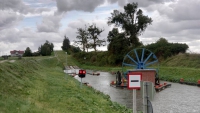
[108,3,152,47]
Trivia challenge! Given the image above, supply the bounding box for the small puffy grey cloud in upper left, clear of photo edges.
[37,16,62,32]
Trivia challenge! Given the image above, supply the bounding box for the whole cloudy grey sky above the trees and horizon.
[0,0,200,55]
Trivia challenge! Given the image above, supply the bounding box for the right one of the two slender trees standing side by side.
[88,24,105,52]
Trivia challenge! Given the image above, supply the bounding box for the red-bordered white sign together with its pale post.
[127,72,142,113]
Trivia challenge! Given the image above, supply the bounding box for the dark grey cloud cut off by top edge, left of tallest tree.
[56,0,105,12]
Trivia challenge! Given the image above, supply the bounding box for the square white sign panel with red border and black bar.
[128,72,142,89]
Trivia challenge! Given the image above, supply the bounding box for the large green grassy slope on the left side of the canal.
[0,52,131,113]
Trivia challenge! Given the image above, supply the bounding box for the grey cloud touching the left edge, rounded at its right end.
[0,10,23,31]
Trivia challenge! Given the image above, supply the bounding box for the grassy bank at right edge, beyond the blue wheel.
[160,54,200,83]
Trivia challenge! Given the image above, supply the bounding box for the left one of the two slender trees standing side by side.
[75,27,89,52]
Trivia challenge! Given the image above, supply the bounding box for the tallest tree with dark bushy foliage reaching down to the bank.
[104,3,153,65]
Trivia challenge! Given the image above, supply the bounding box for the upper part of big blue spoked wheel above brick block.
[122,48,159,75]
